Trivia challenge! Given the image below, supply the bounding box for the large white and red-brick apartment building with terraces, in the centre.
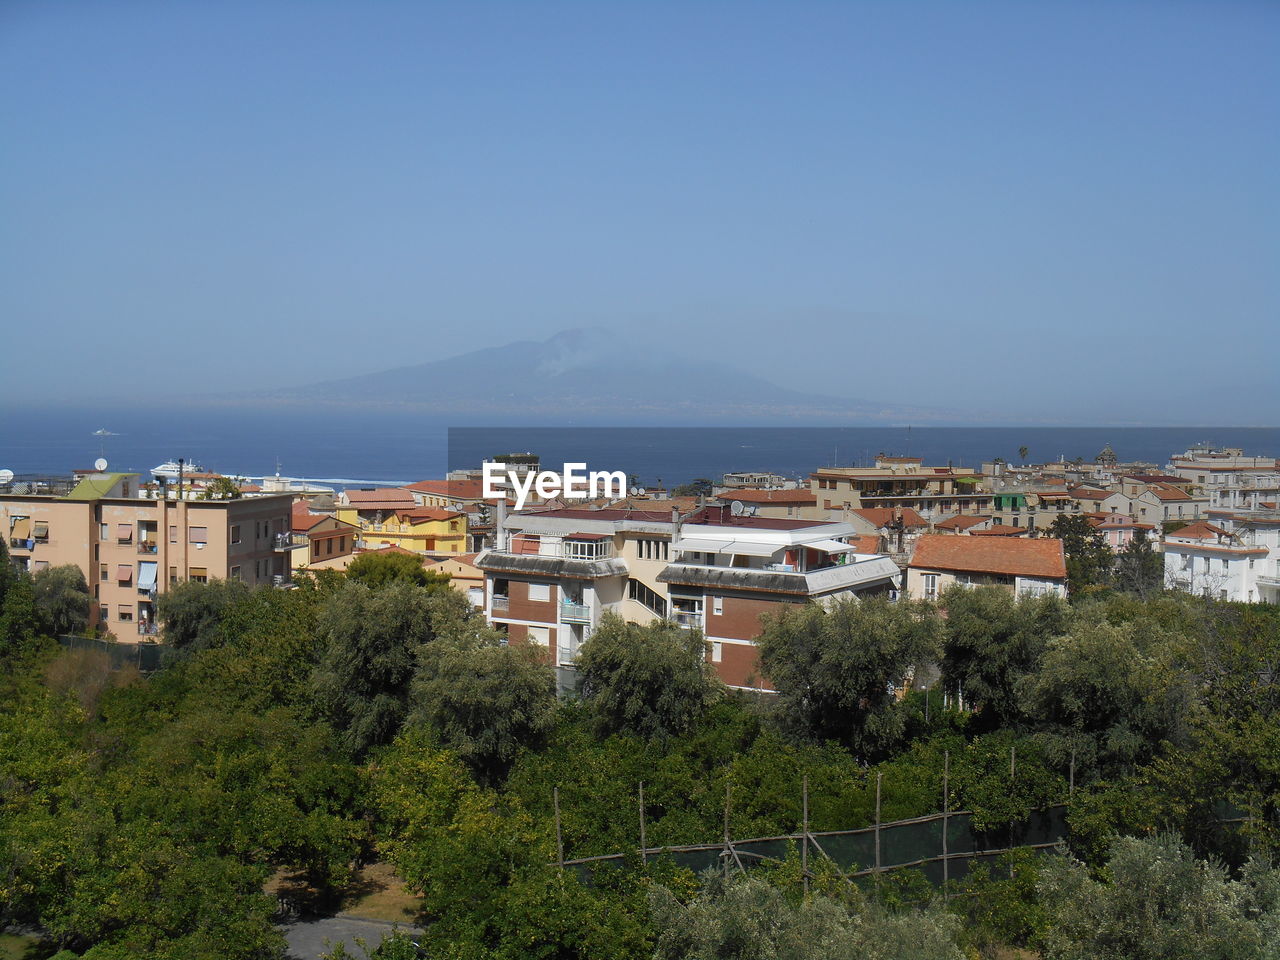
[476,506,899,689]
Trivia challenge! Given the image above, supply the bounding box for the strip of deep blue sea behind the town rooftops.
[0,402,1280,488]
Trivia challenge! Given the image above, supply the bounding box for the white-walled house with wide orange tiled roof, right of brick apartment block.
[906,534,1066,600]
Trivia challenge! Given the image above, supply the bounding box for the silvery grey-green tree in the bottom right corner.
[1039,836,1280,960]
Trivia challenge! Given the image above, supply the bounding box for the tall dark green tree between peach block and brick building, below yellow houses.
[311,581,466,756]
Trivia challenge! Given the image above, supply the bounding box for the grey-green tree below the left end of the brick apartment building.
[413,641,556,785]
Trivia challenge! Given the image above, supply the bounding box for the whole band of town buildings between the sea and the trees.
[0,445,1280,691]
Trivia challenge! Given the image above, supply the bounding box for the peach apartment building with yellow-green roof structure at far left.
[0,474,293,641]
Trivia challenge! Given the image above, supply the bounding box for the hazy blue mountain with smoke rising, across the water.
[243,330,961,424]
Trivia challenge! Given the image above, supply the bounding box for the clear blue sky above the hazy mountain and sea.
[0,0,1280,425]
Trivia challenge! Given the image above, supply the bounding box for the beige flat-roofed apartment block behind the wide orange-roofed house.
[809,457,991,521]
